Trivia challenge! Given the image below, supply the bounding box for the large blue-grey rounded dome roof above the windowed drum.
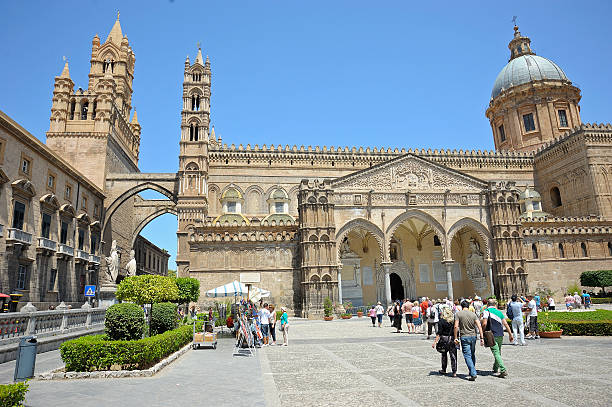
[491,54,569,98]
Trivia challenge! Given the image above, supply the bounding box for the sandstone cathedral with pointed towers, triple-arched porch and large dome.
[1,15,612,317]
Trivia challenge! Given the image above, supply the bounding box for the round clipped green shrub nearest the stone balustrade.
[104,303,145,341]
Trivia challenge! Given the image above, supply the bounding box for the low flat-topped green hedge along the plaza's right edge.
[538,310,612,336]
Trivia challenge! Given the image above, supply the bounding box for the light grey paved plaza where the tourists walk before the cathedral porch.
[0,318,612,407]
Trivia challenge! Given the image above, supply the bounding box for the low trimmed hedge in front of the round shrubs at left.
[60,326,193,372]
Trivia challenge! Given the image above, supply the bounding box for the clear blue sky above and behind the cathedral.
[0,0,612,268]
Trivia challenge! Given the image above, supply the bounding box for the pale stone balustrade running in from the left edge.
[0,304,106,345]
